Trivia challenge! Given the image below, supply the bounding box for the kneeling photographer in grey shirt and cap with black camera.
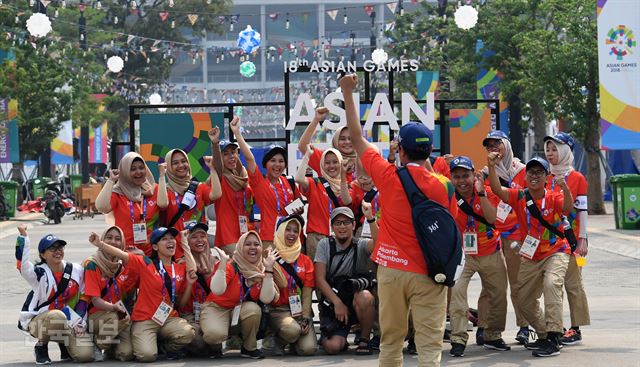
[315,206,378,355]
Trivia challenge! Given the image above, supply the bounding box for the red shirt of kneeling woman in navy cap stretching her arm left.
[127,254,187,321]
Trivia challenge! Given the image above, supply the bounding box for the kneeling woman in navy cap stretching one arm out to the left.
[89,227,196,362]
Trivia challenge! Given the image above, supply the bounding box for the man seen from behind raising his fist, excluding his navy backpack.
[342,75,458,366]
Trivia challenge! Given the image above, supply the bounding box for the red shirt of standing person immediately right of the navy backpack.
[455,186,500,257]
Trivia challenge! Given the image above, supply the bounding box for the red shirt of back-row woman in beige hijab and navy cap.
[215,177,253,247]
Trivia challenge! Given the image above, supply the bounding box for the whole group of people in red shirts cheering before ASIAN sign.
[16,75,590,366]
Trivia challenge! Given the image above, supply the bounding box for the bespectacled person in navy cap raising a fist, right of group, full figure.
[487,152,573,357]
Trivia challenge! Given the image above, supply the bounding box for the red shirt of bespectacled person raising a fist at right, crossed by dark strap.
[507,189,571,261]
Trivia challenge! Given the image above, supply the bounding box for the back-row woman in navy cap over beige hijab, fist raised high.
[209,126,253,256]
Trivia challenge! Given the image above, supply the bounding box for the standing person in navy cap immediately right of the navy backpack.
[449,156,511,357]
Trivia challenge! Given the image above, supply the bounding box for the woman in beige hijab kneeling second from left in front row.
[84,226,138,361]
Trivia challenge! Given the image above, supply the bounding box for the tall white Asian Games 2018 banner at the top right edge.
[597,0,640,149]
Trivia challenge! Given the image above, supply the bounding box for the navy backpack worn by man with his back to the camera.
[396,167,464,287]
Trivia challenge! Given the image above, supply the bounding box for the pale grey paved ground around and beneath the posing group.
[0,210,640,367]
